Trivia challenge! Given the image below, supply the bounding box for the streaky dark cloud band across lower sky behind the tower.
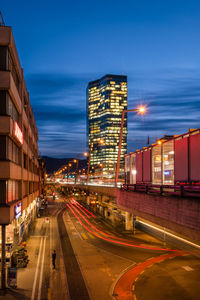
[26,69,200,157]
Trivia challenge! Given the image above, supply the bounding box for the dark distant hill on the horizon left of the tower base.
[42,156,87,174]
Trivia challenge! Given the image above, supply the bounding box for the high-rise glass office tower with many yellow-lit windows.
[87,74,127,178]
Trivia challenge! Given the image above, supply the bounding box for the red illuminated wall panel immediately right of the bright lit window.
[174,138,188,182]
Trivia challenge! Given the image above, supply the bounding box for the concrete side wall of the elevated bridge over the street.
[54,185,200,242]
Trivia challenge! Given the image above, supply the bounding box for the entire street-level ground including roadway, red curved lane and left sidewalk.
[0,198,200,300]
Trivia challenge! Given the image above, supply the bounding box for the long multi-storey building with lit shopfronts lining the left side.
[0,25,39,246]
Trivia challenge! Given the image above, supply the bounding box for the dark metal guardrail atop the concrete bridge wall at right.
[122,183,200,198]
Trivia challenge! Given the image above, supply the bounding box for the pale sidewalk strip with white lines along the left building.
[0,203,68,300]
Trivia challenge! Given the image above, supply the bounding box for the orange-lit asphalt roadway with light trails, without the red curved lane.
[61,197,200,300]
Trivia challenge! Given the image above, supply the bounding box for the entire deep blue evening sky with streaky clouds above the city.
[0,0,200,157]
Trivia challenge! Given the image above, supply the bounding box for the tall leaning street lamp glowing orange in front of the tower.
[115,106,146,186]
